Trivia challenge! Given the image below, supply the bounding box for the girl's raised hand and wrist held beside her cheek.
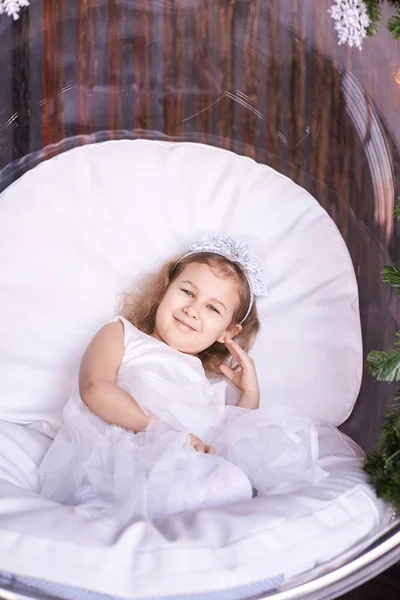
[220,337,260,408]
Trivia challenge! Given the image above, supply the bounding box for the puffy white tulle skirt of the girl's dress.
[39,396,325,525]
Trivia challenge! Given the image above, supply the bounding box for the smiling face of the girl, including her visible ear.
[152,262,242,354]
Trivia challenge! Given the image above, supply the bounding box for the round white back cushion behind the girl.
[0,140,362,433]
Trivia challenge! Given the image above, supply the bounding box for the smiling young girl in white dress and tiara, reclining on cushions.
[39,237,322,523]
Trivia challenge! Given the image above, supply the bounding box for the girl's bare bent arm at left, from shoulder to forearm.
[79,321,150,433]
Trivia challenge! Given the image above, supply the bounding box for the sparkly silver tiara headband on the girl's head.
[178,235,267,323]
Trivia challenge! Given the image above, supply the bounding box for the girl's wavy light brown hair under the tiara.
[120,252,260,377]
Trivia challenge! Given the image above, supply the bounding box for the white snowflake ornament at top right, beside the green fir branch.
[328,0,370,50]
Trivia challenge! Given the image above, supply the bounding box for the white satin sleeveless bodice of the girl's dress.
[114,316,226,437]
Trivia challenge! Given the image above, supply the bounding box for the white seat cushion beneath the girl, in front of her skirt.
[0,421,387,598]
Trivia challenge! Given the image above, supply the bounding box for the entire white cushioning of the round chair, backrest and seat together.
[0,141,386,597]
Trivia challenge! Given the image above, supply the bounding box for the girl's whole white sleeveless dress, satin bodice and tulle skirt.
[39,317,325,524]
